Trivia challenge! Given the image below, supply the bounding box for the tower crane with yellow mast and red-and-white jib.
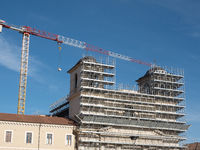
[0,20,151,114]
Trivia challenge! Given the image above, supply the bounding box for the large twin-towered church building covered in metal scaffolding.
[50,56,190,150]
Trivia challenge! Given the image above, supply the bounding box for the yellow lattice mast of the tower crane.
[17,33,30,114]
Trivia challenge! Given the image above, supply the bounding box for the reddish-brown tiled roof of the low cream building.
[0,113,78,126]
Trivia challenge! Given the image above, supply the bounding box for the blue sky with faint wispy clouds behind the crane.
[0,0,200,142]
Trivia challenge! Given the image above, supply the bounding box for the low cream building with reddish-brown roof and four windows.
[0,113,77,150]
